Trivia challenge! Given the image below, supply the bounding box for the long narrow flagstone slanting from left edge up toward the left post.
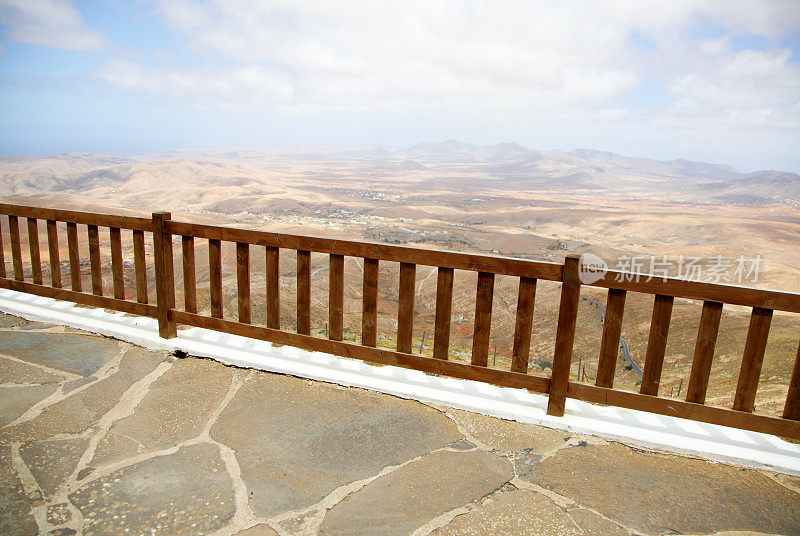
[0,347,168,443]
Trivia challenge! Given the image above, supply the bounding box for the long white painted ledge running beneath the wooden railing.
[0,290,800,476]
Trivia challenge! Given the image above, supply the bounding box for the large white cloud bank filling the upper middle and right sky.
[84,0,800,168]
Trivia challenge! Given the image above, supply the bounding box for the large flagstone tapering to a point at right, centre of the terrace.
[211,374,461,517]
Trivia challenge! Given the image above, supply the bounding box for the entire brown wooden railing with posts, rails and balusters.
[0,204,800,439]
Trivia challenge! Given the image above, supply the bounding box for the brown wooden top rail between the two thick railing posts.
[166,220,563,281]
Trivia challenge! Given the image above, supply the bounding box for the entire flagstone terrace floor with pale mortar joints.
[0,315,800,536]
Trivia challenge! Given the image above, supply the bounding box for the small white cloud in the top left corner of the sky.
[0,0,106,50]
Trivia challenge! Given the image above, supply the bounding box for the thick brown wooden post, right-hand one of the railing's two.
[547,255,581,417]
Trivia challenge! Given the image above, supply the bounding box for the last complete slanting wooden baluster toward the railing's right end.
[733,307,772,412]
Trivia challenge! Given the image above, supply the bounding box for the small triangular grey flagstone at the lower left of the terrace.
[19,438,89,498]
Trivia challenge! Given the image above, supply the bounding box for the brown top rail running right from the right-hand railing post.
[587,270,800,313]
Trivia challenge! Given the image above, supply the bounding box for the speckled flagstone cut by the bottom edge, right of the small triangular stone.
[69,443,235,536]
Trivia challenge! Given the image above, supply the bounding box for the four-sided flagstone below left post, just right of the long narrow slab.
[105,359,234,450]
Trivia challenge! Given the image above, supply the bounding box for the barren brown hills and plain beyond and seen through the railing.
[0,141,800,413]
